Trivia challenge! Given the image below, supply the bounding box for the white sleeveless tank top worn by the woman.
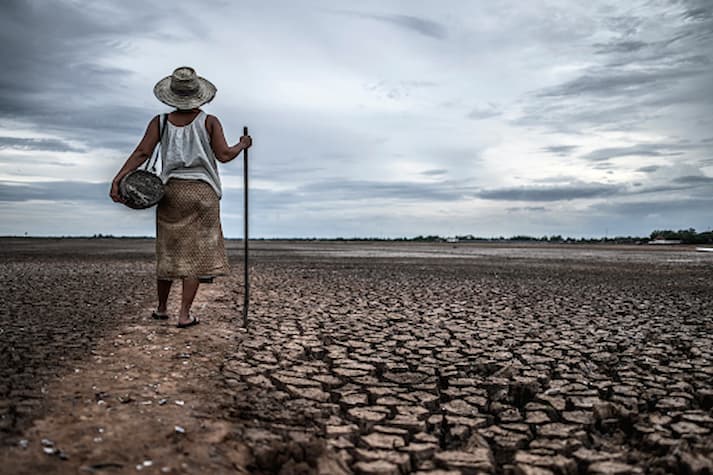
[159,111,223,198]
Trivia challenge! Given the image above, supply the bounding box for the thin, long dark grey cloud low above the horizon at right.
[477,183,622,202]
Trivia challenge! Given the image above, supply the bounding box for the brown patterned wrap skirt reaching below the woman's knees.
[156,179,230,280]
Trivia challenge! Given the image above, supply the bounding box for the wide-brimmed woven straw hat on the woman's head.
[153,66,216,109]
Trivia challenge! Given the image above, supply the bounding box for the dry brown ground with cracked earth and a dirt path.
[0,239,713,475]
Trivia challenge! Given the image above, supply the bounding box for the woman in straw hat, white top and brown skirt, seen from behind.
[110,67,252,328]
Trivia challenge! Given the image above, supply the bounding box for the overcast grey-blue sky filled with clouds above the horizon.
[0,0,713,237]
